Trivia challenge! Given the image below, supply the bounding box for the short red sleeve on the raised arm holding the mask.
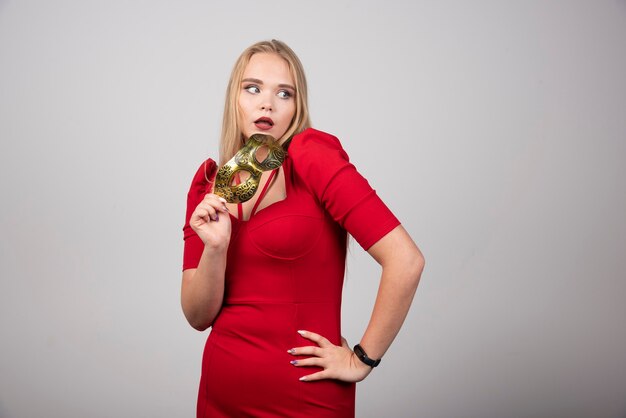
[183,158,217,270]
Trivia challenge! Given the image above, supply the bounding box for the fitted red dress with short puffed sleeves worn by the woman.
[183,129,399,417]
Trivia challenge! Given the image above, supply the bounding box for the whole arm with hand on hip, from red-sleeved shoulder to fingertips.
[289,129,424,381]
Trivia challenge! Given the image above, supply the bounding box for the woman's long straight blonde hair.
[220,39,311,164]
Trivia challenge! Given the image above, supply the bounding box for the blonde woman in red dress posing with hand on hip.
[181,40,424,417]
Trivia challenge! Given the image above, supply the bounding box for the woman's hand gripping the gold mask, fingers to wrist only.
[189,193,231,247]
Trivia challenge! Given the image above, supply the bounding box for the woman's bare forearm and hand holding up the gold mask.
[181,194,231,331]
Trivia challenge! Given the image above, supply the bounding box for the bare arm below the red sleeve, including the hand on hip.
[290,226,424,381]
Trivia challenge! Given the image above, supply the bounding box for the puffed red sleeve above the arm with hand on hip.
[289,129,400,250]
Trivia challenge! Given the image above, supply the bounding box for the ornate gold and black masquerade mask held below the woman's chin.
[214,134,287,203]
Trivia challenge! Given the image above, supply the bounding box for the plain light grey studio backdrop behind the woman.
[0,0,626,418]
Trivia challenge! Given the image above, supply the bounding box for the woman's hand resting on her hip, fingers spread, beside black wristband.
[288,331,372,382]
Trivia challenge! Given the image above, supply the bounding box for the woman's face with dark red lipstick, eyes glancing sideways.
[239,53,296,139]
